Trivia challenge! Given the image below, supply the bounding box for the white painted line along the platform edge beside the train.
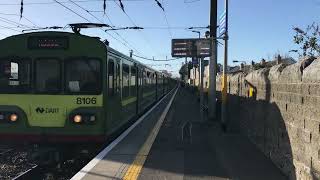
[70,87,179,180]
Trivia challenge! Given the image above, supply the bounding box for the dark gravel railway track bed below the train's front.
[0,144,99,180]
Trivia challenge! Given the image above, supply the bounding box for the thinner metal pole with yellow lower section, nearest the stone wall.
[221,0,229,131]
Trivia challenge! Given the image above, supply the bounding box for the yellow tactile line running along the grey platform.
[122,88,179,180]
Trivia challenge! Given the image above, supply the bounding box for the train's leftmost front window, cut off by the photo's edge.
[0,59,31,93]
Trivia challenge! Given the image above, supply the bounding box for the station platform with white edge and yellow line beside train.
[72,87,286,180]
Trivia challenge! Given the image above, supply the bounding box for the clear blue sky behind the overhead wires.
[0,0,320,76]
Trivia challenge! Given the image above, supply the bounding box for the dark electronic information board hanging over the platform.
[171,39,211,58]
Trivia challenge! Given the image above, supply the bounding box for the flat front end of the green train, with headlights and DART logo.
[0,32,106,142]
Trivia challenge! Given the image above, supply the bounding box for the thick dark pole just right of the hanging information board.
[208,0,217,120]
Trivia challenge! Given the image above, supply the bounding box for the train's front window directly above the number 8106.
[65,59,101,94]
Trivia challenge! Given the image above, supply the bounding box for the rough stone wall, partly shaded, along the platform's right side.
[217,58,320,179]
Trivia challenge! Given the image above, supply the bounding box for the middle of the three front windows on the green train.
[35,59,61,93]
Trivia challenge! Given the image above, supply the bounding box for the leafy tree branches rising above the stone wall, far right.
[293,23,320,57]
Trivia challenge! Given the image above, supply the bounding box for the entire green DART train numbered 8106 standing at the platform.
[0,31,176,142]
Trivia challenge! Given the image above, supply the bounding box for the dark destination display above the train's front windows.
[28,36,69,49]
